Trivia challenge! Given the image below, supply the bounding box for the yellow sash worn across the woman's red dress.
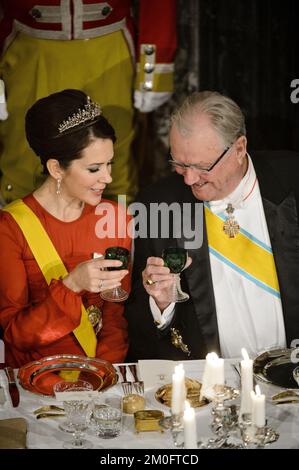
[3,199,97,357]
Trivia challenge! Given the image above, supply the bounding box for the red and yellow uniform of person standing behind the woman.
[0,0,176,201]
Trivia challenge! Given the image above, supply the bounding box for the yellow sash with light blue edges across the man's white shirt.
[205,205,280,297]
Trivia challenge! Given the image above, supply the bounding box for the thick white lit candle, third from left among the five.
[200,352,224,399]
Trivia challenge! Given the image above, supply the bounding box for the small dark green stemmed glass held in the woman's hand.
[100,246,130,302]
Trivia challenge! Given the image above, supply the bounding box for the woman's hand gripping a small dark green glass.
[62,258,129,293]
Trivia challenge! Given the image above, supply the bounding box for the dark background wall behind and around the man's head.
[137,0,299,186]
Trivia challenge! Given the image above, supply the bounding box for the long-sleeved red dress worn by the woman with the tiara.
[0,195,131,367]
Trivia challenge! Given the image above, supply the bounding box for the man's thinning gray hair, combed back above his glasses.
[170,91,246,146]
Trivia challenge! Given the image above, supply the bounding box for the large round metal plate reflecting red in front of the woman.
[18,354,117,396]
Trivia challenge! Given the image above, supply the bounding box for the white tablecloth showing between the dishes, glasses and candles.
[0,360,299,449]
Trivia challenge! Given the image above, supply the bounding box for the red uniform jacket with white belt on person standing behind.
[0,0,176,107]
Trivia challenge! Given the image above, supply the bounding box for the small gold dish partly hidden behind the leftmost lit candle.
[155,378,210,408]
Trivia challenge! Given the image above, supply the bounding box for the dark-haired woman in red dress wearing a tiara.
[0,90,131,367]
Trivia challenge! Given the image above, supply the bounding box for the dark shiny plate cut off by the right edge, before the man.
[253,348,298,390]
